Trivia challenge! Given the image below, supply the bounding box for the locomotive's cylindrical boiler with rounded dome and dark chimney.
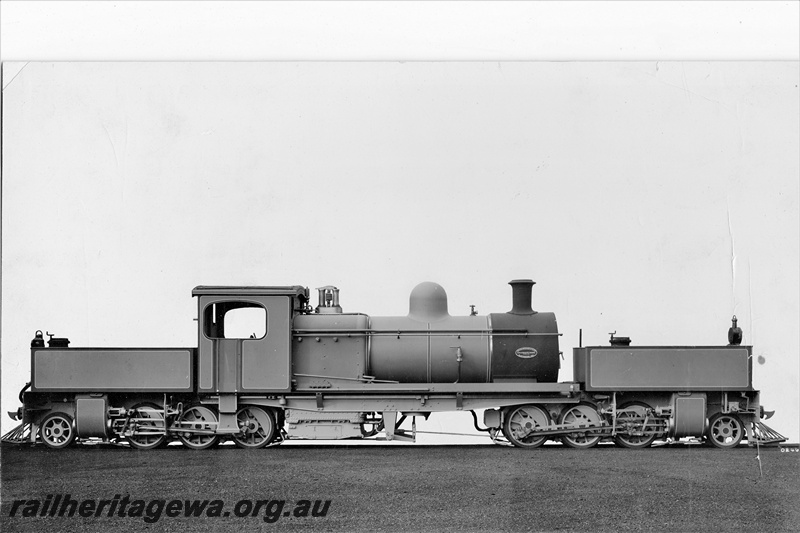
[293,280,559,383]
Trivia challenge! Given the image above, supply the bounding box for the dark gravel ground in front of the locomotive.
[0,445,800,532]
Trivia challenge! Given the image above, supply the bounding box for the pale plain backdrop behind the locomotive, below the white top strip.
[2,61,800,442]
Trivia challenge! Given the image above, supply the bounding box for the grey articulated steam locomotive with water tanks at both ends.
[4,279,785,449]
